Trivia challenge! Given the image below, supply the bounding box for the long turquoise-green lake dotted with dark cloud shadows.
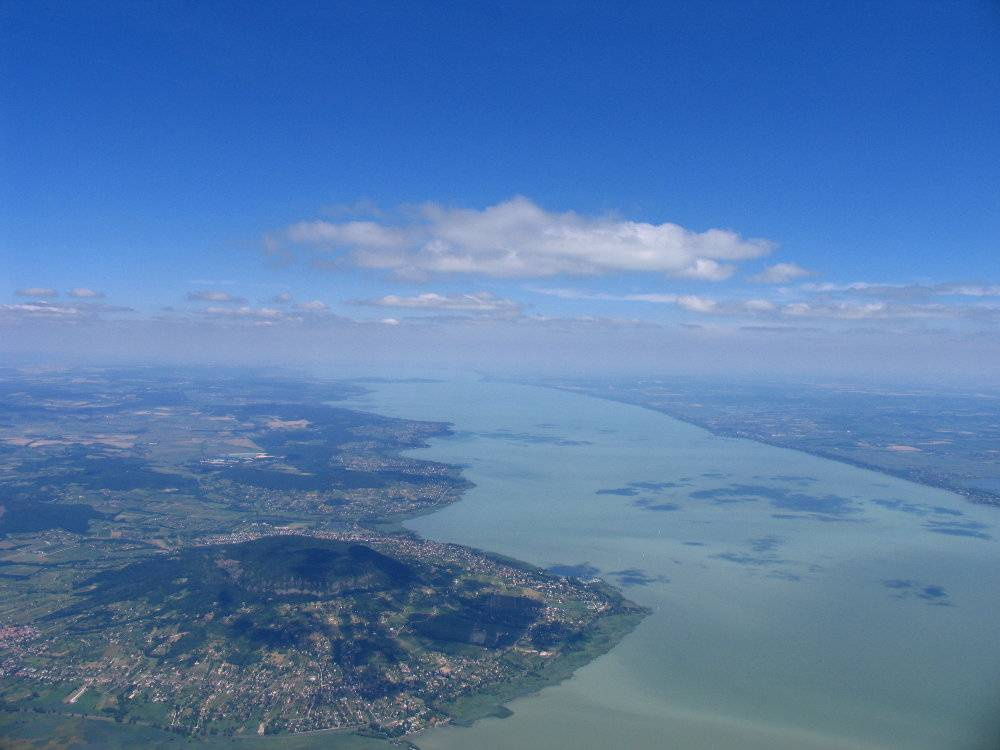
[342,381,1000,750]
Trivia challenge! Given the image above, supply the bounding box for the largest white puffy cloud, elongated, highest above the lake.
[268,197,772,281]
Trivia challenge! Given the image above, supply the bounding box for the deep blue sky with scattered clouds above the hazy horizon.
[0,2,1000,382]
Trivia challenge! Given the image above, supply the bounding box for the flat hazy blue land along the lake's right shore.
[539,378,1000,506]
